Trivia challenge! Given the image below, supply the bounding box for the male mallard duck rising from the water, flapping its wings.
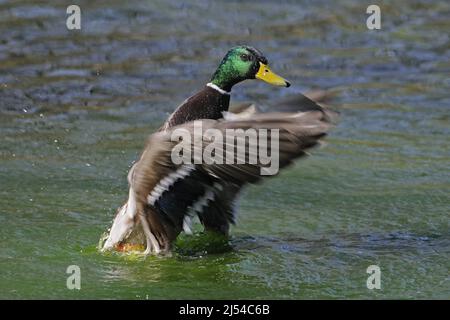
[102,46,332,254]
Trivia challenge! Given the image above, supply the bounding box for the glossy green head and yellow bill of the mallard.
[211,46,290,91]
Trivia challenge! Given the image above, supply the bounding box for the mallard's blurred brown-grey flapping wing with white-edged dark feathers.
[130,110,331,233]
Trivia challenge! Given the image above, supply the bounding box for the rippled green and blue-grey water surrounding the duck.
[0,0,450,299]
